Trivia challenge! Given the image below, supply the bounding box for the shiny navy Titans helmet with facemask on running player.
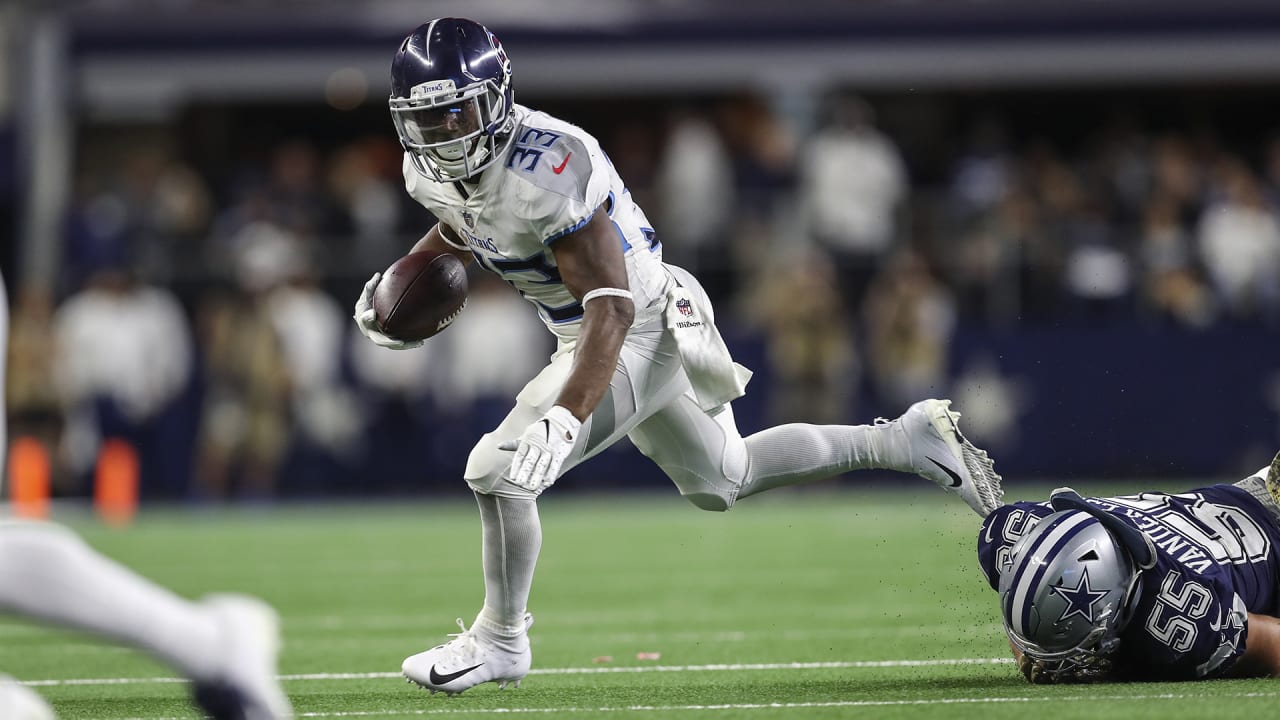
[389,18,515,182]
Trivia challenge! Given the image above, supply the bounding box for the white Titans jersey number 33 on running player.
[403,105,673,341]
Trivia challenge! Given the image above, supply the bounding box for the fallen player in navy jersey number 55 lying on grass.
[978,455,1280,683]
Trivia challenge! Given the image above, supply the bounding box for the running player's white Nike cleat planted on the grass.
[401,614,534,694]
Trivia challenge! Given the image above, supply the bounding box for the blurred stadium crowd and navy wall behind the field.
[0,0,1280,503]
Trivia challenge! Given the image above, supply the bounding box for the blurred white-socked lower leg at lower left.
[0,521,219,678]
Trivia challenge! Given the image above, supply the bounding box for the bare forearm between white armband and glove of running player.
[556,297,635,420]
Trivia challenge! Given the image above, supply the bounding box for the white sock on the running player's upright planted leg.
[476,493,543,637]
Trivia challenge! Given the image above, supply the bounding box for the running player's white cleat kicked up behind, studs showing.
[890,400,1005,518]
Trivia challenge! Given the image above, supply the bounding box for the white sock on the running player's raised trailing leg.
[737,423,910,498]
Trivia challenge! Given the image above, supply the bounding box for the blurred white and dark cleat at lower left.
[192,594,293,720]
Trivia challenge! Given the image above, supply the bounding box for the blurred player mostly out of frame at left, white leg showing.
[0,269,293,720]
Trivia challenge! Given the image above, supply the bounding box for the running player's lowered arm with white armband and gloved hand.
[499,209,635,493]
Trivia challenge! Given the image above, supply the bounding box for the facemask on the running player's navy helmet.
[389,79,513,182]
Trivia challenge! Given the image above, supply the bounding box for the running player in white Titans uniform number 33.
[355,18,1000,694]
